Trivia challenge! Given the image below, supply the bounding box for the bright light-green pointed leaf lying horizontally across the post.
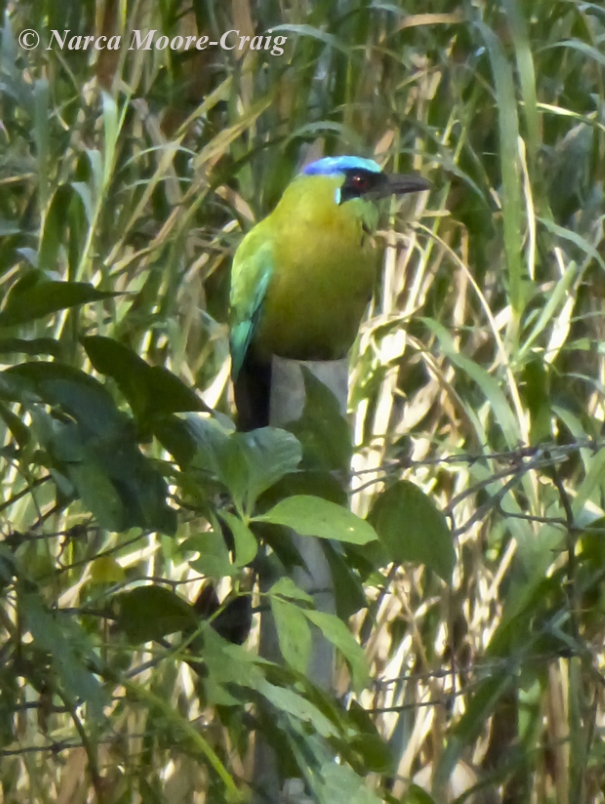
[254,494,377,544]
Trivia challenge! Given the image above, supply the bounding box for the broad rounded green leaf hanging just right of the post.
[368,480,456,583]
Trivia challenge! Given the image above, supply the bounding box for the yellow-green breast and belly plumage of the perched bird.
[254,179,376,360]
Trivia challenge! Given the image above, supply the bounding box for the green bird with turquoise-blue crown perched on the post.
[229,155,430,431]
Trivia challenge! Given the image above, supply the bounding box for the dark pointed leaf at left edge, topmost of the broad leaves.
[0,271,119,327]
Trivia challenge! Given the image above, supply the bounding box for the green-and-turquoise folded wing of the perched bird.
[229,236,273,380]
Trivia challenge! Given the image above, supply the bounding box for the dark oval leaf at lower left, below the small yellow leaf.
[111,586,198,644]
